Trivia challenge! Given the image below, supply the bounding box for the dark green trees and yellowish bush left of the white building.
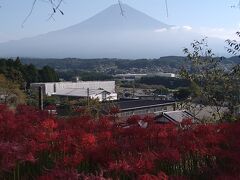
[0,58,59,107]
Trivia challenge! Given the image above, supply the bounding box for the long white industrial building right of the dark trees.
[31,81,117,101]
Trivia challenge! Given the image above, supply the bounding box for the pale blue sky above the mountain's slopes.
[0,0,240,42]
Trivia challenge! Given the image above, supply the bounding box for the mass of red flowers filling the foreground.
[0,105,240,180]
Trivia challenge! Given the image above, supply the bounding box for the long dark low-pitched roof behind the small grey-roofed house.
[111,99,175,111]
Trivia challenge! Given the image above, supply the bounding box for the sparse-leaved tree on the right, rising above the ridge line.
[180,39,240,120]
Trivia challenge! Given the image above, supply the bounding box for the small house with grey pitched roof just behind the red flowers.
[155,110,199,124]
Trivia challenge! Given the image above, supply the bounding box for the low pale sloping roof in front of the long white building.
[54,88,109,97]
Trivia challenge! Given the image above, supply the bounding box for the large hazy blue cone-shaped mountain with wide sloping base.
[0,4,224,59]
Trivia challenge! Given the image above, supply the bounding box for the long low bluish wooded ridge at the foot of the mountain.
[20,56,240,75]
